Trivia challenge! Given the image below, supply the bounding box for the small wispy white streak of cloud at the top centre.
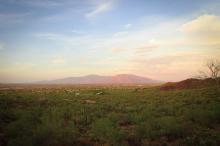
[85,1,113,19]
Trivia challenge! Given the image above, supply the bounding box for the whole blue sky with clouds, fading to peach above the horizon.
[0,0,220,83]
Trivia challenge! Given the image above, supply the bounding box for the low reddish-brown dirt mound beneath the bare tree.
[160,78,216,90]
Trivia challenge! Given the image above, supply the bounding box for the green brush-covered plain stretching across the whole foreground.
[0,86,220,146]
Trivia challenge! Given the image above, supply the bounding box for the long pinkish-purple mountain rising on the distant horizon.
[37,74,159,84]
